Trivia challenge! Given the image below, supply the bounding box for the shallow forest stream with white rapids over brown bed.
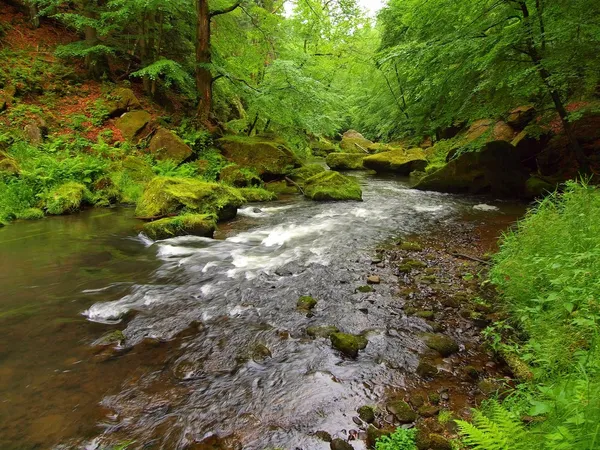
[0,175,511,449]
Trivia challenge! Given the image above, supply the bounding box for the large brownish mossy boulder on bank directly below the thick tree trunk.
[217,136,300,179]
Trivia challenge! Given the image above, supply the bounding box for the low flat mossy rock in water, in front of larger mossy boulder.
[143,214,217,240]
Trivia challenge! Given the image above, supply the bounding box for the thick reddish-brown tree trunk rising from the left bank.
[196,0,212,123]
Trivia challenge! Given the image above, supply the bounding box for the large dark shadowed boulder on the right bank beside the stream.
[414,141,529,197]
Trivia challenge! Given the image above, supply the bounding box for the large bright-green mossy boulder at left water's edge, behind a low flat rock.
[135,177,246,220]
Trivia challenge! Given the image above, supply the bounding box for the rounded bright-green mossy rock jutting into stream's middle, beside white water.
[304,171,362,201]
